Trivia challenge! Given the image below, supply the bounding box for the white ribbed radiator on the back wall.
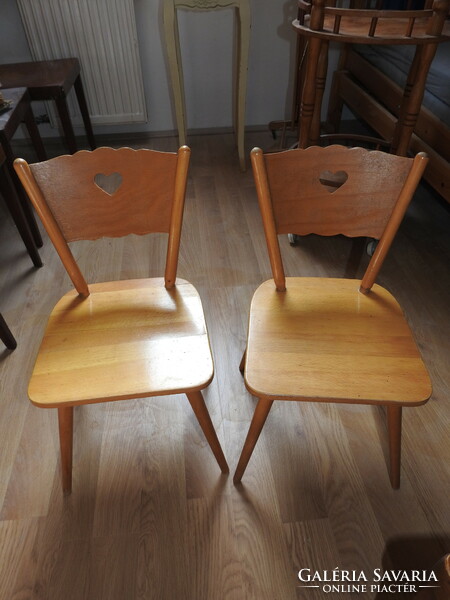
[17,0,147,125]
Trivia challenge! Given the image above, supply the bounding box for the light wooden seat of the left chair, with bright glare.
[29,278,213,407]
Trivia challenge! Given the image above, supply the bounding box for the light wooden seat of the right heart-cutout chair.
[245,277,431,406]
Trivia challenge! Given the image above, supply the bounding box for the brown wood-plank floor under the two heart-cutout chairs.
[0,133,450,600]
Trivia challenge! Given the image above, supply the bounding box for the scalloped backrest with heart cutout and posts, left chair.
[14,146,190,296]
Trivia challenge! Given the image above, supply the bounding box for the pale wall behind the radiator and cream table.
[0,0,336,135]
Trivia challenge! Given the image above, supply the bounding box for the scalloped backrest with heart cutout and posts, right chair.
[251,146,428,293]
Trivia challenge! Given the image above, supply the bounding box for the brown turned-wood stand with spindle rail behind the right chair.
[293,0,450,156]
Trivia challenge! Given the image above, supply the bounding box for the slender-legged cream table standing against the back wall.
[164,0,250,170]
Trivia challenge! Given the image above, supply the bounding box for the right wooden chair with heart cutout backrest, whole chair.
[234,146,431,488]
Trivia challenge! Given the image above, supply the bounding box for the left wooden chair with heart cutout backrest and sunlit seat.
[15,147,228,492]
